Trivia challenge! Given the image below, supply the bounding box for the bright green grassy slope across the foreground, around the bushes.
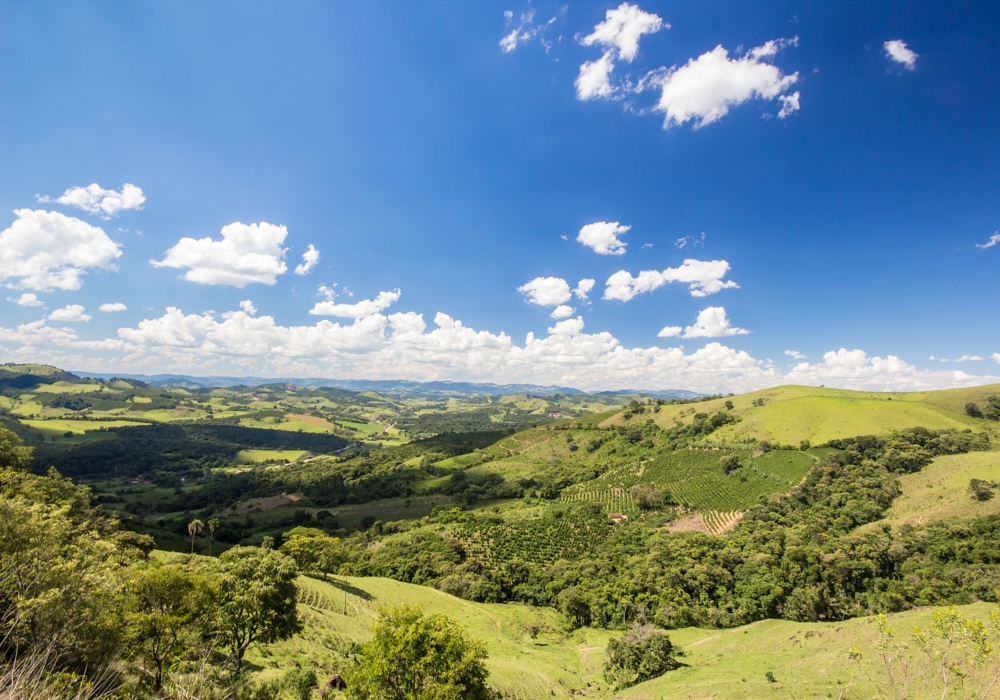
[234,576,996,700]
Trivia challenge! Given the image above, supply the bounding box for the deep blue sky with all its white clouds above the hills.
[0,2,1000,391]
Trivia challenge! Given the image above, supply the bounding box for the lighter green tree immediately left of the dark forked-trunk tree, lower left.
[126,564,212,691]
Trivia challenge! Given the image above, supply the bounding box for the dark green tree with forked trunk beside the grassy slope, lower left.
[215,547,302,671]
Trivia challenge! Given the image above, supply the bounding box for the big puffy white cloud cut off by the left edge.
[0,209,122,291]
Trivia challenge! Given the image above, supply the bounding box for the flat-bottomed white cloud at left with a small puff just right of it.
[150,221,288,289]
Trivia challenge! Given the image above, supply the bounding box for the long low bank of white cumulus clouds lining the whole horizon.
[7,303,1000,393]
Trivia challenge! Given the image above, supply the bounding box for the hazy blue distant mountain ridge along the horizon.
[73,372,704,399]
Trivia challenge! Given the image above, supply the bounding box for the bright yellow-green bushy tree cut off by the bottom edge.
[345,605,498,700]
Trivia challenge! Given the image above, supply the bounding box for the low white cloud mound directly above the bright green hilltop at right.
[785,348,998,391]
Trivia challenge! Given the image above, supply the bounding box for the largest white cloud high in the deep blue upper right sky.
[654,39,799,129]
